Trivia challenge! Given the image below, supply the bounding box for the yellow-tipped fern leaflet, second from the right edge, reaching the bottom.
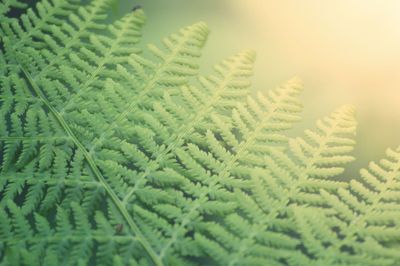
[198,107,355,265]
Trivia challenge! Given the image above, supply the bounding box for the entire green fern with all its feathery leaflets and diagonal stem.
[0,0,400,265]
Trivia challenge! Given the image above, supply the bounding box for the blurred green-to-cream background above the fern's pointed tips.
[113,0,400,178]
